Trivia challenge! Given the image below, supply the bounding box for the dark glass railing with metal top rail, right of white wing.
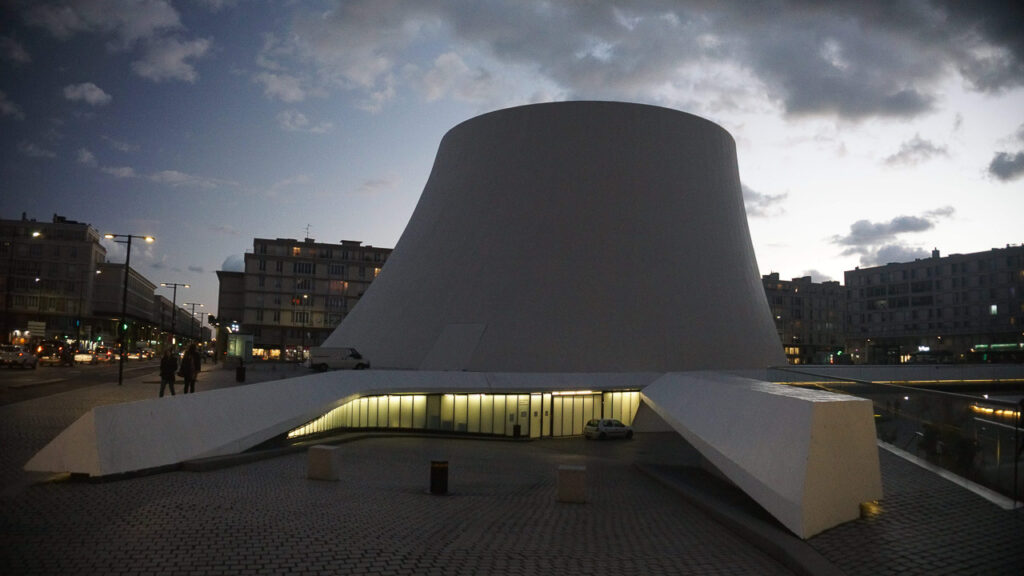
[769,367,1024,504]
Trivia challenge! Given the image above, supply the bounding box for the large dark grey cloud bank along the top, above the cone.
[284,0,1024,120]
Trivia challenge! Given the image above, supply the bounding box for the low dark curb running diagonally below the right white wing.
[634,462,846,576]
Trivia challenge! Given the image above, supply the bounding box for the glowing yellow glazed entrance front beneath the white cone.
[288,390,640,439]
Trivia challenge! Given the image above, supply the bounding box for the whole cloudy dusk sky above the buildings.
[0,0,1024,312]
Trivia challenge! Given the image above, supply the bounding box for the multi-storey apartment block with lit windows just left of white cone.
[229,238,391,361]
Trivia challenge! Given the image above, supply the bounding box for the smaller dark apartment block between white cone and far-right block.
[761,273,847,364]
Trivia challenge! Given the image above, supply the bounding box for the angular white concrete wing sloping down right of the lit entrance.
[642,372,882,538]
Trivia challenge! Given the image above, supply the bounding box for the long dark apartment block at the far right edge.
[845,245,1024,364]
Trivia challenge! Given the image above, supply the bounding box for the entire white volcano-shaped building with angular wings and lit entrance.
[27,101,882,537]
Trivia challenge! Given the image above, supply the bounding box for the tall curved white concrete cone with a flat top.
[324,101,784,372]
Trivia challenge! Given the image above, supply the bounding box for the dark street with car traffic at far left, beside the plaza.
[0,360,160,406]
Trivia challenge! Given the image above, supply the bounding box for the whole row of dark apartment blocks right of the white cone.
[762,244,1024,364]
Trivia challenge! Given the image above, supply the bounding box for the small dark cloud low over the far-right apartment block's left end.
[831,206,955,266]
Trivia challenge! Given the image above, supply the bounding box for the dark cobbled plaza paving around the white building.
[0,365,1024,575]
